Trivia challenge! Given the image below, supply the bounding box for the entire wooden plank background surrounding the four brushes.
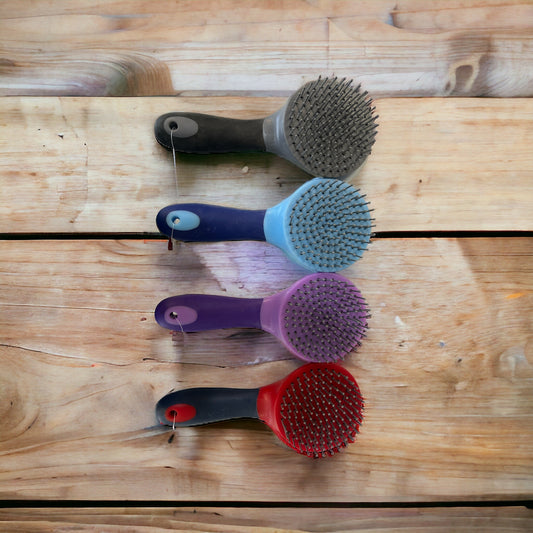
[0,0,533,532]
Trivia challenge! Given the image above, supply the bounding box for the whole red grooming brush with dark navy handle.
[156,363,364,457]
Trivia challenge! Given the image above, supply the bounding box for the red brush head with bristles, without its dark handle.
[257,363,364,457]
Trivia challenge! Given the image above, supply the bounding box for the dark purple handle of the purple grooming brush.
[155,294,263,332]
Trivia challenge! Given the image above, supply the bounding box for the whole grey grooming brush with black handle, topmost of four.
[154,78,377,178]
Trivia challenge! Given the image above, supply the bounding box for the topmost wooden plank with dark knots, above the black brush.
[0,0,533,97]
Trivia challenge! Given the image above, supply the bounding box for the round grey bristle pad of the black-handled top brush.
[284,78,377,178]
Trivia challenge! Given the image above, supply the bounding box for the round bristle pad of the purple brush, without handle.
[282,273,368,363]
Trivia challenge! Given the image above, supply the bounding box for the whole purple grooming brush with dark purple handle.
[155,273,369,362]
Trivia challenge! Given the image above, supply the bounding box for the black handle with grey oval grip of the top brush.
[154,113,266,154]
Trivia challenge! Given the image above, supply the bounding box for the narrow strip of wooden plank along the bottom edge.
[0,507,533,533]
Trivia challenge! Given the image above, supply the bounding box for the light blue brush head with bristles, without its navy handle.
[264,178,372,272]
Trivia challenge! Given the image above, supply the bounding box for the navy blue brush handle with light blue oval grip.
[156,204,265,242]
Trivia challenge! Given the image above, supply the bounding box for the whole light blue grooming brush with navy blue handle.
[156,178,372,272]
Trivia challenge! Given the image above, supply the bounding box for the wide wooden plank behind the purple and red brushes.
[0,238,533,502]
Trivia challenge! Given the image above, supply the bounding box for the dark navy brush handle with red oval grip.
[156,387,259,427]
